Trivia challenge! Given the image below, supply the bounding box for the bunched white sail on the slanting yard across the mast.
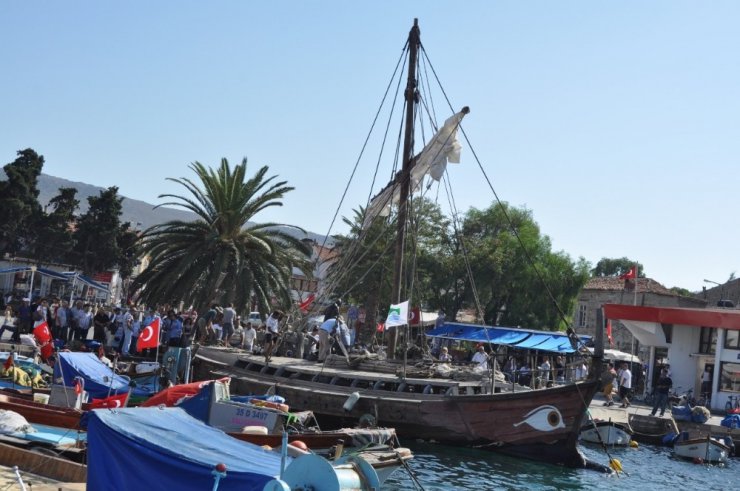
[363,108,468,227]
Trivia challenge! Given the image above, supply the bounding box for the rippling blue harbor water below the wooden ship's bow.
[383,441,740,491]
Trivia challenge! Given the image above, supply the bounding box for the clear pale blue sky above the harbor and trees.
[0,0,740,290]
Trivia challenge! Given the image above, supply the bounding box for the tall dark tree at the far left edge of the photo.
[0,148,44,254]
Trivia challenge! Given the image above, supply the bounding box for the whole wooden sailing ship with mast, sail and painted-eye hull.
[194,20,602,467]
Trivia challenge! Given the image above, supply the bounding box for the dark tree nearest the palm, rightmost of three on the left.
[72,186,123,274]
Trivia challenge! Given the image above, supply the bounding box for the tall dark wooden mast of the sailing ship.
[387,19,421,359]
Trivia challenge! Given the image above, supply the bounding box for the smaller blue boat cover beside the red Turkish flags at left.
[54,351,129,399]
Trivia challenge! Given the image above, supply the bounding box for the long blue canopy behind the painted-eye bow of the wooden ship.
[426,322,591,353]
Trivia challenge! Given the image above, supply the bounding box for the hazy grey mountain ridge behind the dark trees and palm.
[38,174,333,245]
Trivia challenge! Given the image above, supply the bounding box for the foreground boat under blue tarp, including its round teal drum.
[84,407,379,491]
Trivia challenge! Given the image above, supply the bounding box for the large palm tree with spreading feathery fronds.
[133,158,310,312]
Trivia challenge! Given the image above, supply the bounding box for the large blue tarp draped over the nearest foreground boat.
[83,407,290,491]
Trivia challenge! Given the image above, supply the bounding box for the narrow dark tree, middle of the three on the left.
[35,188,80,263]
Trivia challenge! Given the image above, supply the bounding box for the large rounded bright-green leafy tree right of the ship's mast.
[456,204,588,329]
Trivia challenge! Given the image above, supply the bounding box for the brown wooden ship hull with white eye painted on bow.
[196,348,597,467]
